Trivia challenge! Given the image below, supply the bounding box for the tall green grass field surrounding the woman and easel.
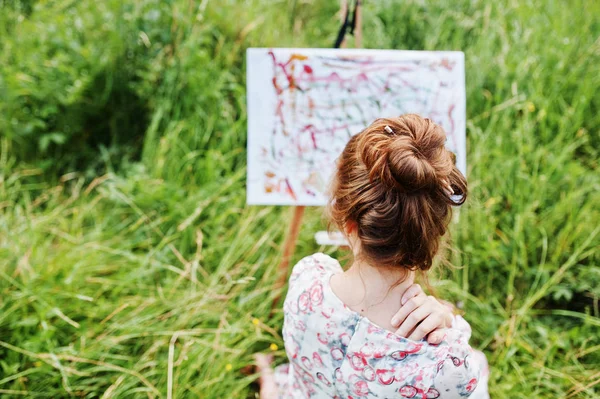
[0,0,600,399]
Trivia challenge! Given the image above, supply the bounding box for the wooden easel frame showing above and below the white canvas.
[271,0,362,311]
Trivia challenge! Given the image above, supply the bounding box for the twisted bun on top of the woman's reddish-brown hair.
[358,117,449,193]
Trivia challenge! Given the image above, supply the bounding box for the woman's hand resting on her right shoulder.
[392,284,453,344]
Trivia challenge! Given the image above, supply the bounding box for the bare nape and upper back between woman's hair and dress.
[331,260,414,331]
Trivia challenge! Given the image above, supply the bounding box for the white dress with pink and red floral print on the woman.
[275,253,489,399]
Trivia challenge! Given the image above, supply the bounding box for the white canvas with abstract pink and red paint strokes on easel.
[247,48,466,205]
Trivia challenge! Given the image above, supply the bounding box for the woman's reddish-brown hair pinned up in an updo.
[329,114,467,271]
